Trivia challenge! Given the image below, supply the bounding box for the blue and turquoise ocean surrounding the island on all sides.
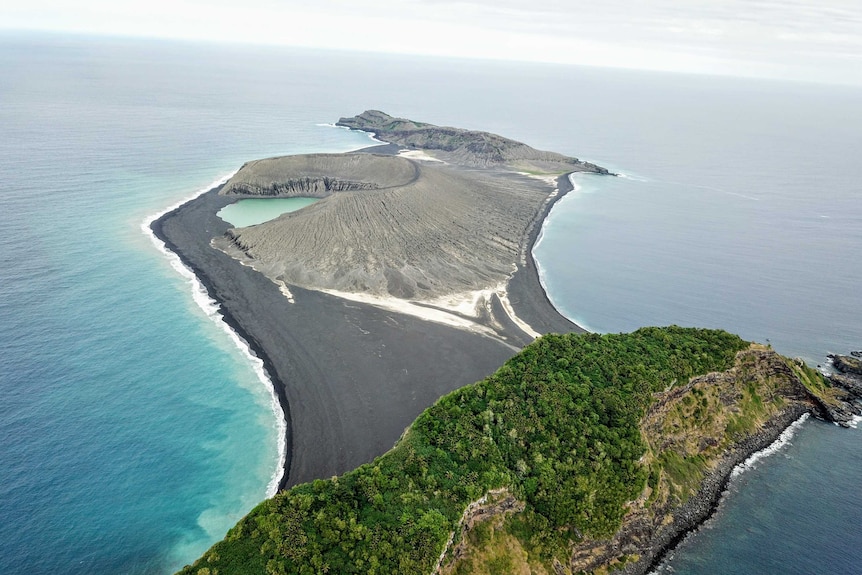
[0,33,862,574]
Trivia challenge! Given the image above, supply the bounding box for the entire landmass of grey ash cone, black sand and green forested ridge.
[162,111,862,575]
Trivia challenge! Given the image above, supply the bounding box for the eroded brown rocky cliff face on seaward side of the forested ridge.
[439,346,833,575]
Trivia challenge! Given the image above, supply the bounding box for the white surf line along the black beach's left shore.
[141,170,287,498]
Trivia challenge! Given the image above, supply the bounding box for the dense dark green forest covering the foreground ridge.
[182,327,748,575]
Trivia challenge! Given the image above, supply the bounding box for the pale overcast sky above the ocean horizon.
[0,0,862,84]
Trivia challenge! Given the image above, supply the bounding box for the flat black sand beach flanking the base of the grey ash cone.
[153,162,580,489]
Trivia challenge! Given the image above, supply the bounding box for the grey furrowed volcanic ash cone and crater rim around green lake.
[214,153,553,300]
